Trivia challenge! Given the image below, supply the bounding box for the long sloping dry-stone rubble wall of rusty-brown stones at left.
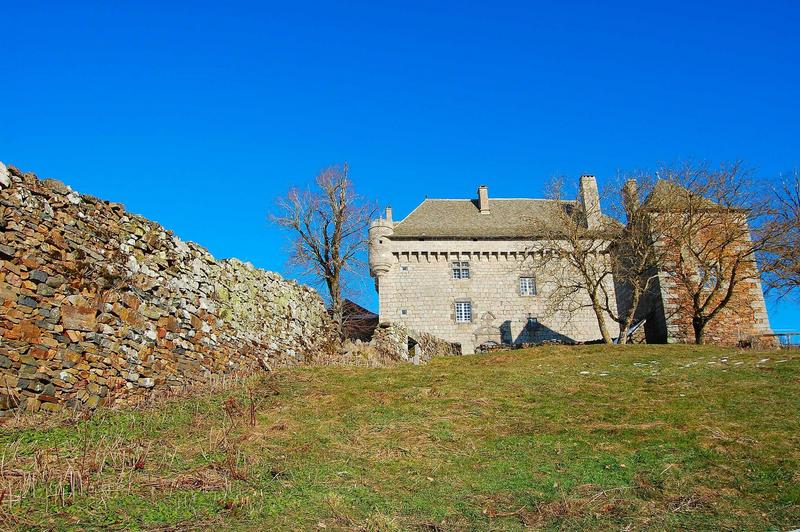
[0,163,335,412]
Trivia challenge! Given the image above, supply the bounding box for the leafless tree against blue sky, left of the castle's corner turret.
[271,164,376,338]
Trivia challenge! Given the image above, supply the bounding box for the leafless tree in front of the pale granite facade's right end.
[532,178,621,343]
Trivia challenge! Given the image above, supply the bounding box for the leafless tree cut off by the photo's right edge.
[763,170,800,297]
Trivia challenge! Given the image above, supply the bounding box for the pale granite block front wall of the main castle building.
[378,241,616,354]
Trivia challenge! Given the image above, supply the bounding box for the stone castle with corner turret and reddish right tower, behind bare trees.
[369,175,771,354]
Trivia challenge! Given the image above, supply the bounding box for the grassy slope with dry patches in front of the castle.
[0,346,800,530]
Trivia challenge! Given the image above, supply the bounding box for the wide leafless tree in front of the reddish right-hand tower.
[646,162,774,344]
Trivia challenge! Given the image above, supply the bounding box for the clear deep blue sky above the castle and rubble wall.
[0,0,800,328]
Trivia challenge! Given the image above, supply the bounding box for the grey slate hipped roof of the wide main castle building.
[392,198,576,238]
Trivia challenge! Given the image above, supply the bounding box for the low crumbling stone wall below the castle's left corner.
[370,323,461,364]
